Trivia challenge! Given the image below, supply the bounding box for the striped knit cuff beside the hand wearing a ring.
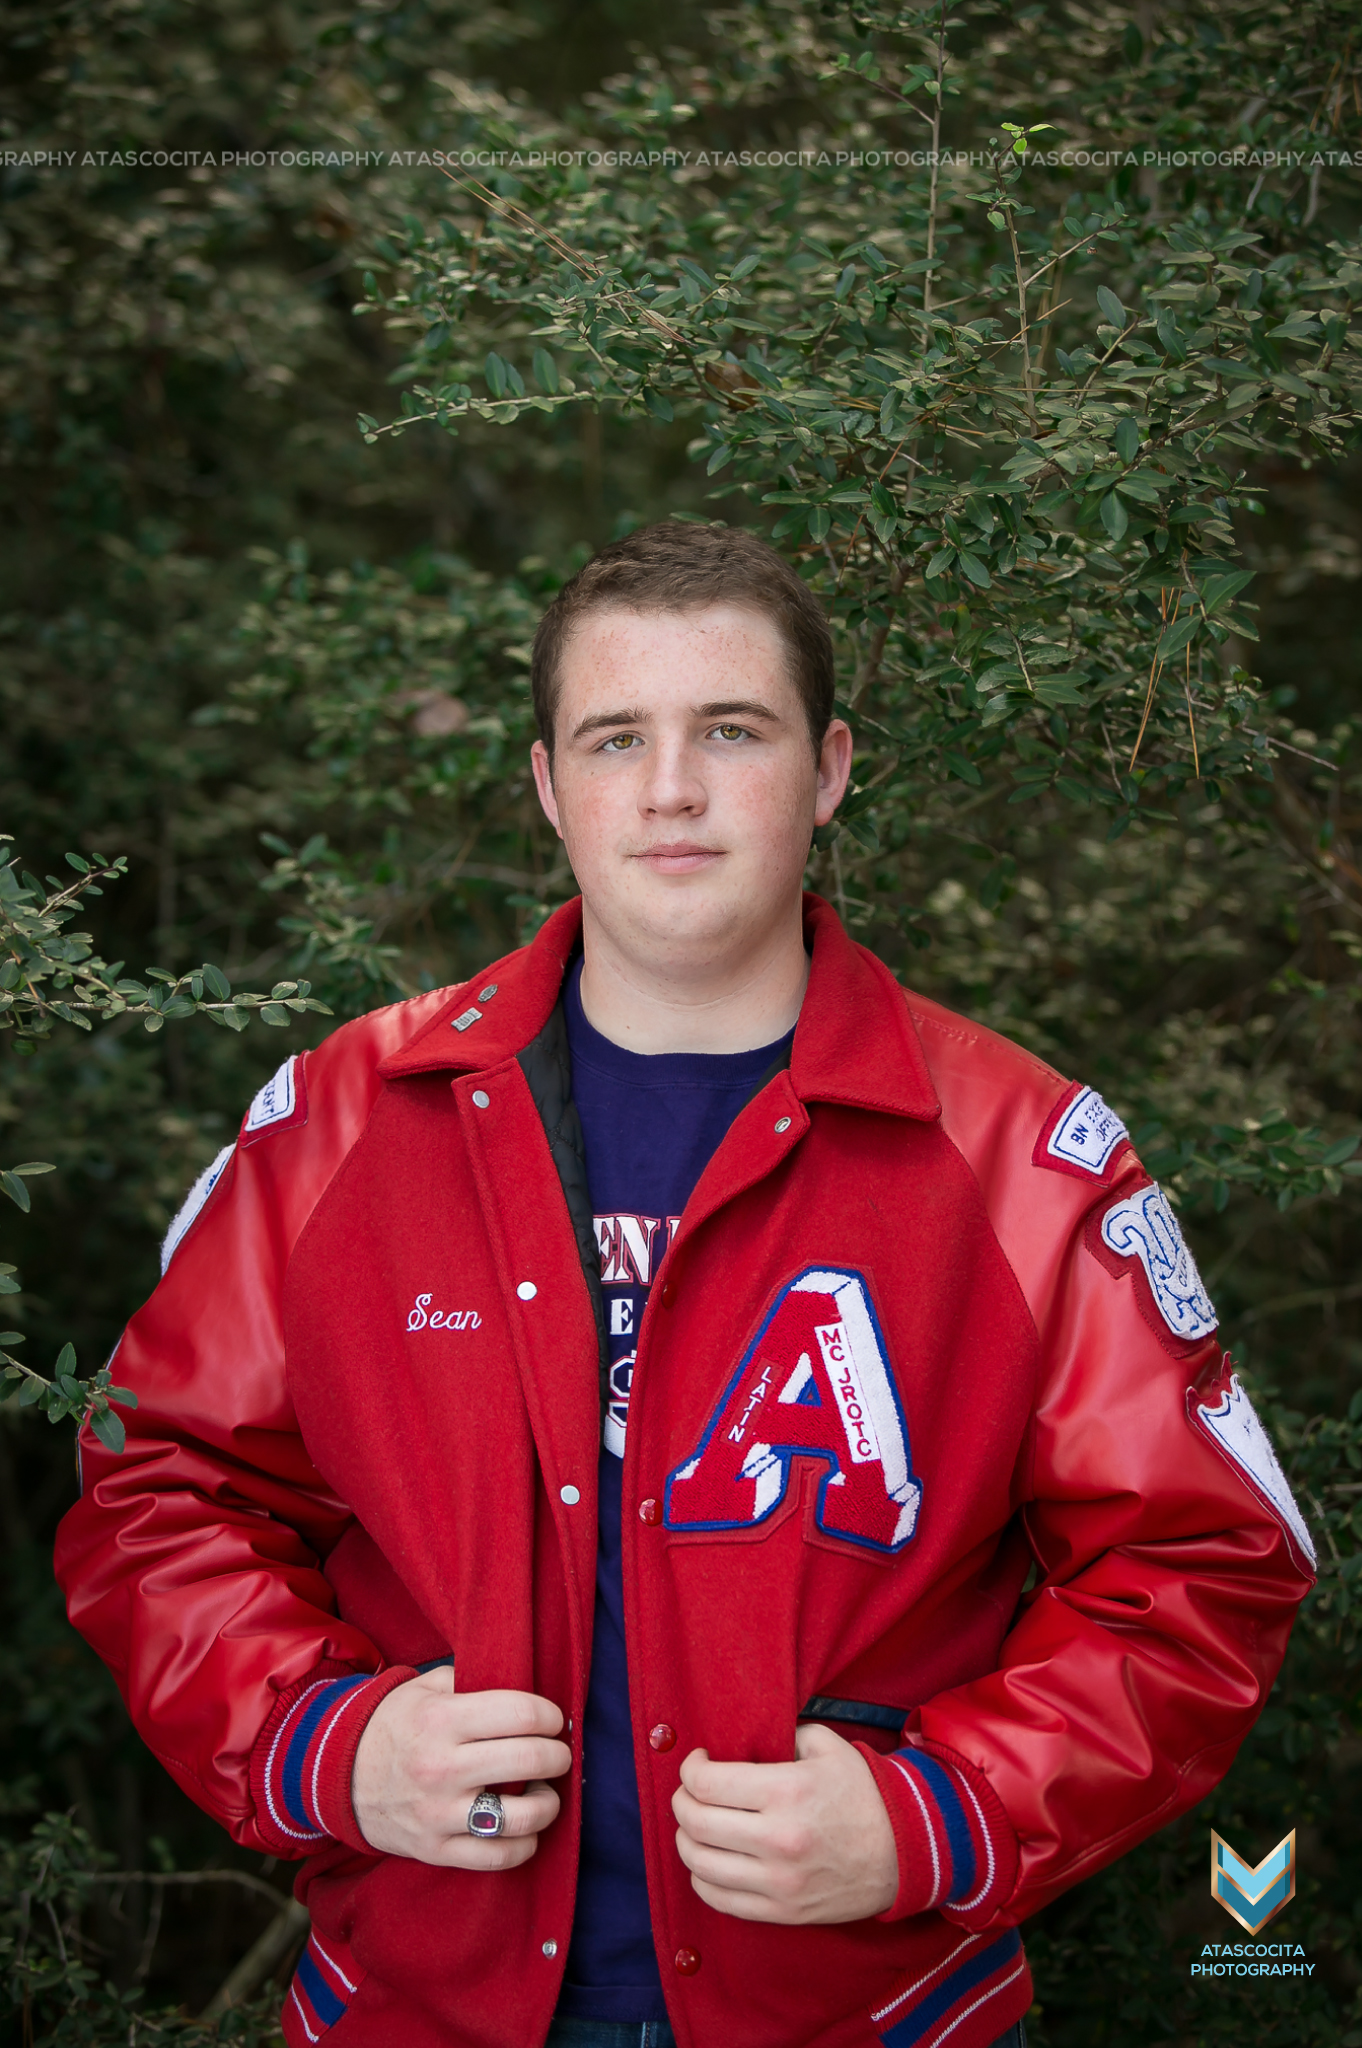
[250,1665,416,1855]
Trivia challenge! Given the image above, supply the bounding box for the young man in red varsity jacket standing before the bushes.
[57,524,1313,2048]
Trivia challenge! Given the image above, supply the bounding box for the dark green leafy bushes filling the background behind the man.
[0,0,1362,2048]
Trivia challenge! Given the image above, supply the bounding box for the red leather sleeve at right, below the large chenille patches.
[909,1006,1311,1925]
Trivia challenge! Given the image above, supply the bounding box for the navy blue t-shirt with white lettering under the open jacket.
[557,961,780,2023]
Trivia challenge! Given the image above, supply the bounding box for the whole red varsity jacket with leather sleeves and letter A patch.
[57,897,1313,2048]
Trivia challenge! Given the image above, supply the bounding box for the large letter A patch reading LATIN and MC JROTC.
[666,1266,922,1550]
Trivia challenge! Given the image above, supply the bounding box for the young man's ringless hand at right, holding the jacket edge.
[672,1722,899,1927]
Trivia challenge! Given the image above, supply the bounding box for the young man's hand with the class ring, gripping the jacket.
[352,1667,571,1870]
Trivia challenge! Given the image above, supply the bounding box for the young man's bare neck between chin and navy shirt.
[582,901,809,1053]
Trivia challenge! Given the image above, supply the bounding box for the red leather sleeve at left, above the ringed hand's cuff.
[55,1032,413,1853]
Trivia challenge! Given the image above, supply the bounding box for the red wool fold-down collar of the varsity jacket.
[379,895,940,1120]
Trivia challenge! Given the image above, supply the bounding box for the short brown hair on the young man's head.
[530,518,834,758]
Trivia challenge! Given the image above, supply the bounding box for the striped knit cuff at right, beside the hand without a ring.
[856,1743,1018,1927]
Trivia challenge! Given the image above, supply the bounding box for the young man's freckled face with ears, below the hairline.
[535,604,850,954]
